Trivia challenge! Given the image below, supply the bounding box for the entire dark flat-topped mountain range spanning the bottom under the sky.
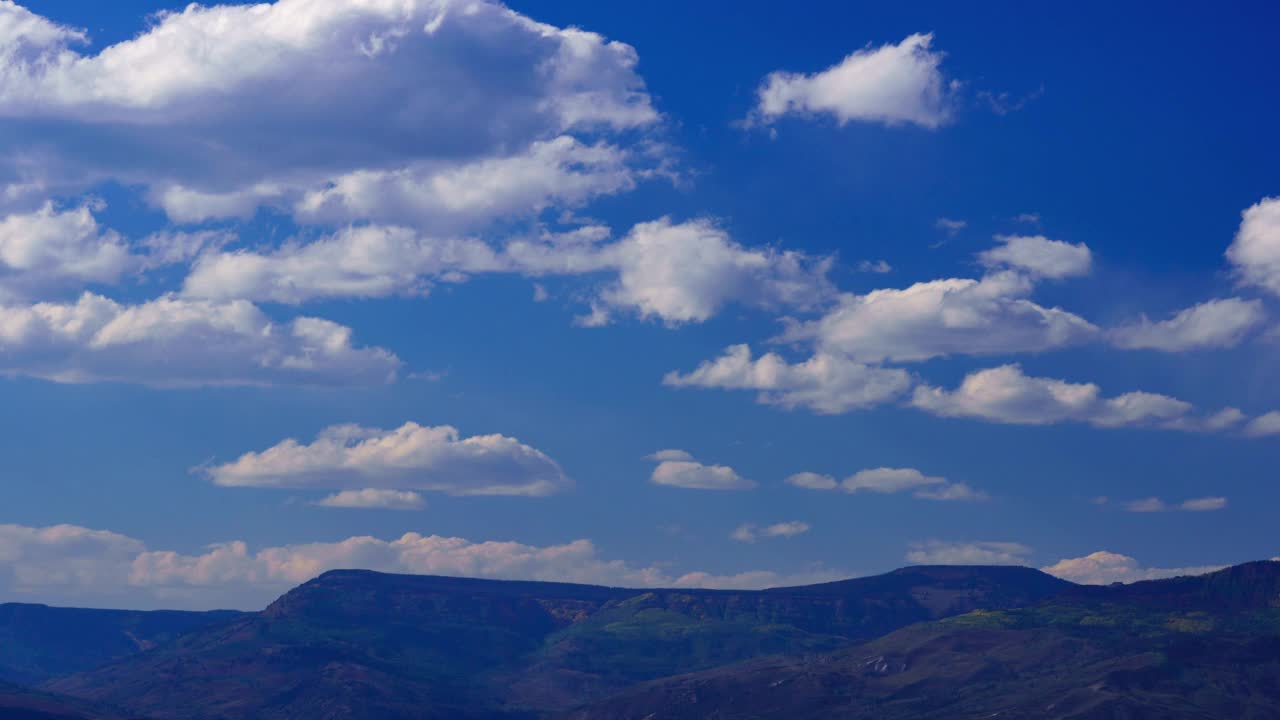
[0,562,1280,720]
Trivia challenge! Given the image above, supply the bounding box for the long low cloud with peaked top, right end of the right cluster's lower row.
[911,365,1192,428]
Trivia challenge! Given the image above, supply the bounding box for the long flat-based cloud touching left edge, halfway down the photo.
[0,293,401,387]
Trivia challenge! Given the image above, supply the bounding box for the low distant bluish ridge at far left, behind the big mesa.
[0,603,242,684]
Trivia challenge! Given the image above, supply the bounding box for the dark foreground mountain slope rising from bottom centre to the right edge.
[566,562,1280,720]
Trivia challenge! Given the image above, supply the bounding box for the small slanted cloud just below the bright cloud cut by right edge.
[1108,297,1267,352]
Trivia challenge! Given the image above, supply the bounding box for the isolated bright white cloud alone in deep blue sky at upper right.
[750,33,951,128]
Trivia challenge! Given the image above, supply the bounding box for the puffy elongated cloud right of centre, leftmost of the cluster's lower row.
[663,345,911,415]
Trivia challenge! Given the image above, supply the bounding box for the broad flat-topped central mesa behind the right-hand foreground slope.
[47,568,1070,720]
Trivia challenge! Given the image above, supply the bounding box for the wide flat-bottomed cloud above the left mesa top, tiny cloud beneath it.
[205,423,568,496]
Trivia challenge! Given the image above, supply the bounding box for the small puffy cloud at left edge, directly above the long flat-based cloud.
[0,198,137,300]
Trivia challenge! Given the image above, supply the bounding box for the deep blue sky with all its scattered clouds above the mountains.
[0,0,1280,607]
